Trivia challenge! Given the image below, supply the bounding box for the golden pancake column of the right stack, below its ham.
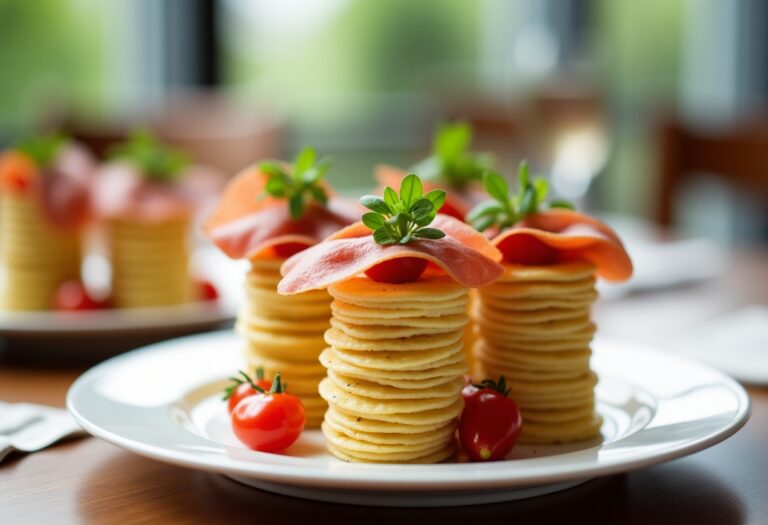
[474,262,602,444]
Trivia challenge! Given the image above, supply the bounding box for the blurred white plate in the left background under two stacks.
[0,249,245,338]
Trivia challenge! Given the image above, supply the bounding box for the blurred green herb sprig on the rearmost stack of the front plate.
[413,122,493,190]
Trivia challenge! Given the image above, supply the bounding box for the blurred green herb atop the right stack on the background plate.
[107,131,189,182]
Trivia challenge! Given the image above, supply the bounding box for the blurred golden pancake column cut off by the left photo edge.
[0,193,81,310]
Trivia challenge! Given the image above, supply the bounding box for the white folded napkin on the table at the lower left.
[0,403,84,461]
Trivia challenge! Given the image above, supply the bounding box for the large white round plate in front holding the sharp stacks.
[67,333,749,506]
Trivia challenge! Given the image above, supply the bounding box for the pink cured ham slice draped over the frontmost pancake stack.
[278,215,504,295]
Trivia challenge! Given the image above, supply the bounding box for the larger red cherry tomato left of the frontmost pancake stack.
[231,373,305,452]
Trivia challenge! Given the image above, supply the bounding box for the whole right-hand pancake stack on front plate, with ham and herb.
[470,164,632,444]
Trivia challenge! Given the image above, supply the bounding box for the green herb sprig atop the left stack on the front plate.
[259,148,332,219]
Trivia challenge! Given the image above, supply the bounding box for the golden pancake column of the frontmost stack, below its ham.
[320,276,469,463]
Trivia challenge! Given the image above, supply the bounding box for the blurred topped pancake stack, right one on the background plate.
[95,134,206,308]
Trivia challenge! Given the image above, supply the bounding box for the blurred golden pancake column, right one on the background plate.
[109,217,194,308]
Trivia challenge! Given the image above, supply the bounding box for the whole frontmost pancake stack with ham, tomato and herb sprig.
[278,175,508,463]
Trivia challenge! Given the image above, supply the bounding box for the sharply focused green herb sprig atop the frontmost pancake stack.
[360,173,445,245]
